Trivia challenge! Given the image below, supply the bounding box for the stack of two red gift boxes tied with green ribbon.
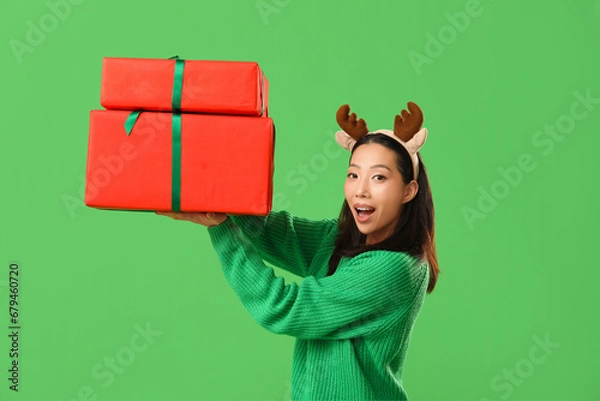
[84,58,275,215]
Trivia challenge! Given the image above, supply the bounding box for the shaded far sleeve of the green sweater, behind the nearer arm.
[230,211,337,277]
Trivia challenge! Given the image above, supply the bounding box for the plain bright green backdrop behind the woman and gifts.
[0,0,600,401]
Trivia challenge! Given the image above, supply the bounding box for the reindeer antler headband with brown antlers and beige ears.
[335,102,427,180]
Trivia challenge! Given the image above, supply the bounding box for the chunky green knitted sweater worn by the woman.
[208,211,429,401]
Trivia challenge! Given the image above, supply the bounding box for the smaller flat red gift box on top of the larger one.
[100,57,268,116]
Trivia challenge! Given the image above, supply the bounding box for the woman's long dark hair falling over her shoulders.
[327,134,440,293]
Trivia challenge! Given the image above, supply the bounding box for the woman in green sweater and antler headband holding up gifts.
[157,103,440,401]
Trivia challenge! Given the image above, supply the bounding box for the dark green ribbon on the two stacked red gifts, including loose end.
[124,56,185,212]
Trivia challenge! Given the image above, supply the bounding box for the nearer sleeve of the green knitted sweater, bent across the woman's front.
[208,219,427,339]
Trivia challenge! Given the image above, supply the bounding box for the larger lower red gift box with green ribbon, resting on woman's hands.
[84,110,275,215]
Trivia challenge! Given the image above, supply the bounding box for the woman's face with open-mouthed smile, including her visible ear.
[344,143,418,245]
